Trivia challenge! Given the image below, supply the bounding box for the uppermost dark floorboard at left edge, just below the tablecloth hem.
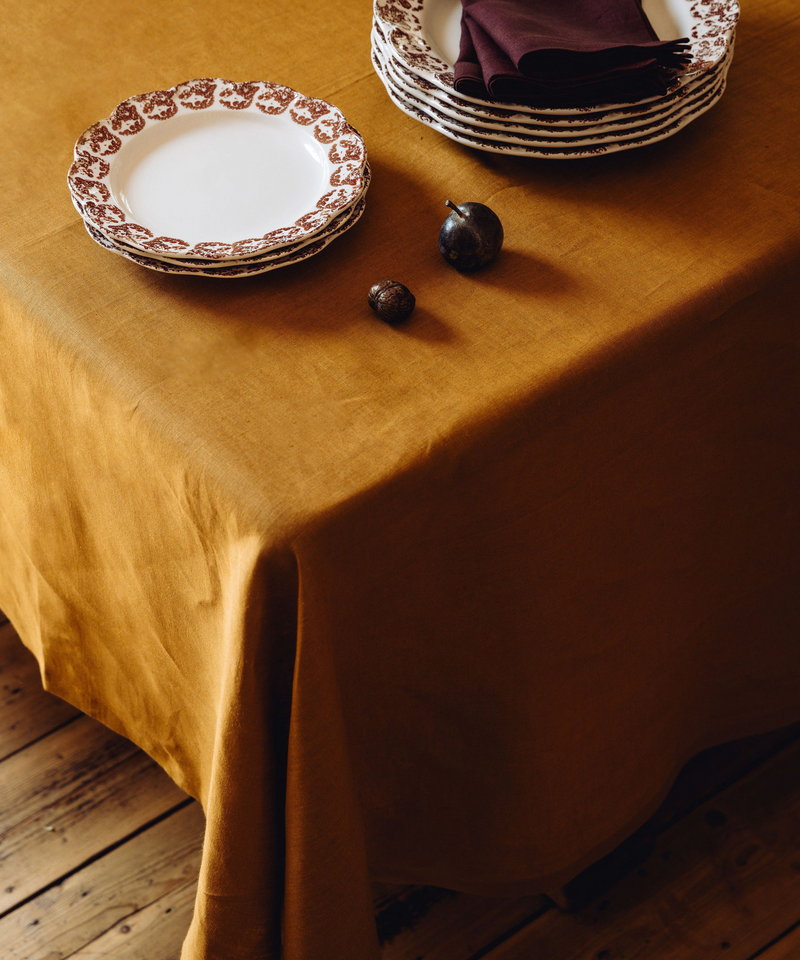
[0,614,80,761]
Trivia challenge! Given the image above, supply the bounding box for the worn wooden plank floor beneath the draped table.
[0,615,800,960]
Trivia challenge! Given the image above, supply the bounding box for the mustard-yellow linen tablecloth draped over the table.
[0,0,800,960]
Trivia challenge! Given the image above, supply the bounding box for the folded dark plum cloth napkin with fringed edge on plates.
[455,0,690,106]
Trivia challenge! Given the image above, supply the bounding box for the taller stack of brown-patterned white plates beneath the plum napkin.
[372,0,739,159]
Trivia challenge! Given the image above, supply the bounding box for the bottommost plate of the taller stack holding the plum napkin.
[372,52,725,160]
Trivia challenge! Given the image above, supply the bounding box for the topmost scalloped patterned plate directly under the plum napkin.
[373,0,739,116]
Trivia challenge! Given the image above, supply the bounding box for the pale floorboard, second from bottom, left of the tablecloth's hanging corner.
[0,802,205,960]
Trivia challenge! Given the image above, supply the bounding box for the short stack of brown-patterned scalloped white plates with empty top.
[67,79,370,277]
